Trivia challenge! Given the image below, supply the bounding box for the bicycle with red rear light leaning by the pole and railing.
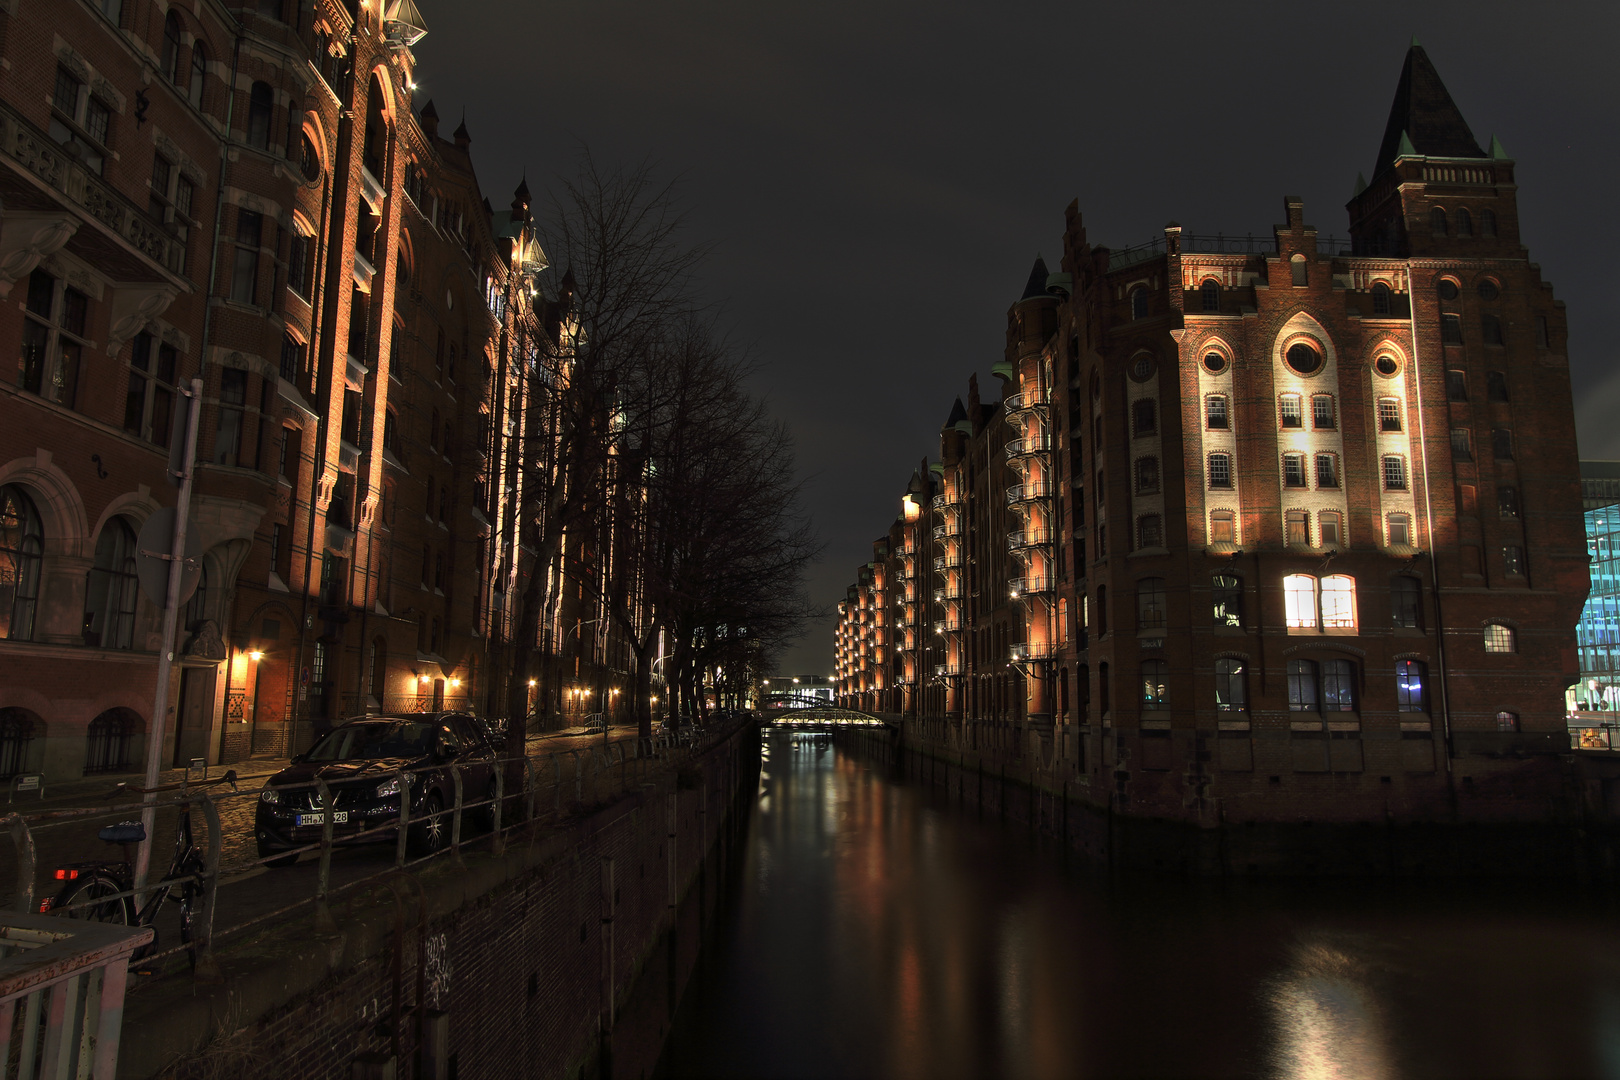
[49,769,237,973]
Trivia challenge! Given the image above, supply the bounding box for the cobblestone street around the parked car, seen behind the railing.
[0,727,670,947]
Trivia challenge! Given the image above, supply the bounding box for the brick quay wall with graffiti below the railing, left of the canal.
[118,725,760,1080]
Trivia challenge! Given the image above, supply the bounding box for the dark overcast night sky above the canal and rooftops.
[416,0,1620,674]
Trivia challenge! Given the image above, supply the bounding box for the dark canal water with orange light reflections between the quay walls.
[663,735,1620,1080]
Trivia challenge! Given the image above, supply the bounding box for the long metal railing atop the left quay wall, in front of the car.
[0,719,752,990]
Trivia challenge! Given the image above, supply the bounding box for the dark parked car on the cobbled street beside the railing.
[254,712,497,866]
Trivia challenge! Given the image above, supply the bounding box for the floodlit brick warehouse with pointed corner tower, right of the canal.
[835,44,1588,823]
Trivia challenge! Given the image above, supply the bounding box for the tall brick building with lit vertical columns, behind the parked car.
[0,0,631,777]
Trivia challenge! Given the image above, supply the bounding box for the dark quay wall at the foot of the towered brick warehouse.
[836,717,1620,881]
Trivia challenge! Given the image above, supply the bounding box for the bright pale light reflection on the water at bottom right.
[1268,944,1396,1080]
